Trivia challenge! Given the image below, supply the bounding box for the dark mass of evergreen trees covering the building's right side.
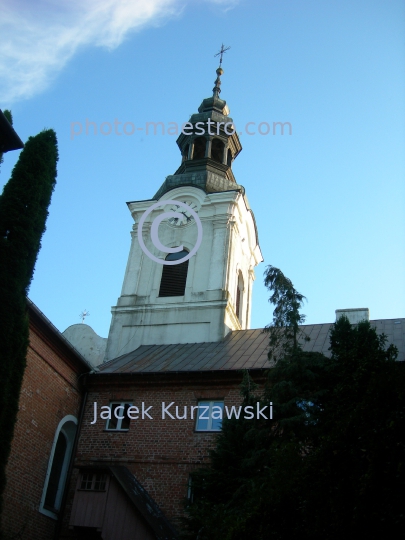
[185,272,405,540]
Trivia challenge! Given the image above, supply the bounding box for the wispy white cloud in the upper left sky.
[0,0,223,107]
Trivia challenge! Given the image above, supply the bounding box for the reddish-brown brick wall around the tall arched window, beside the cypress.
[2,314,85,540]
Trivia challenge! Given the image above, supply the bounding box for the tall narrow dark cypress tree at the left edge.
[0,129,58,524]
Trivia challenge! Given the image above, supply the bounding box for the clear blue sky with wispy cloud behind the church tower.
[0,0,405,336]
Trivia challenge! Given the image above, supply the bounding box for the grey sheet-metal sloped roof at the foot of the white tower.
[99,319,405,373]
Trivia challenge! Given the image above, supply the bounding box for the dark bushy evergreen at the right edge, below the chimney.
[302,317,405,540]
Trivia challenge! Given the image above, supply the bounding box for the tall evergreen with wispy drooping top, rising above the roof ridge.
[182,266,327,540]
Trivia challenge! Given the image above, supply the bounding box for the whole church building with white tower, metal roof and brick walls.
[3,67,405,540]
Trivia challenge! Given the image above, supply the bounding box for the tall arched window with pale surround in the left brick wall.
[39,415,77,519]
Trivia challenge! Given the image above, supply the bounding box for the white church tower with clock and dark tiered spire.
[105,60,263,361]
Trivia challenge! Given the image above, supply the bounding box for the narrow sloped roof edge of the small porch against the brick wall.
[108,466,177,540]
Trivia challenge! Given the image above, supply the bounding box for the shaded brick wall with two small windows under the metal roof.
[65,372,264,532]
